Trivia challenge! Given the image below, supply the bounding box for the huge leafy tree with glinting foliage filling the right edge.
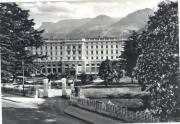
[136,1,180,121]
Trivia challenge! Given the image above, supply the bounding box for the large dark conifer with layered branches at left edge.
[0,3,43,81]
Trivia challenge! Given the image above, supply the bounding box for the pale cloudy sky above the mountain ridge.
[14,0,172,28]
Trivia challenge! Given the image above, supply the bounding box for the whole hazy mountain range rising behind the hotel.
[39,8,154,39]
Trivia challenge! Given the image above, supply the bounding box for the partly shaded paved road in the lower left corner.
[2,99,87,124]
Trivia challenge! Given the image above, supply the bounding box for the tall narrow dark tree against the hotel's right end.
[121,31,140,83]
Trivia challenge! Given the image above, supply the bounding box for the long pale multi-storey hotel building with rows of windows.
[32,38,124,75]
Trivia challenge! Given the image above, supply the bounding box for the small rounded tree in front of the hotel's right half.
[98,59,114,86]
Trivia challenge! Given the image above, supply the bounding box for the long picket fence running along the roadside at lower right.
[70,96,159,122]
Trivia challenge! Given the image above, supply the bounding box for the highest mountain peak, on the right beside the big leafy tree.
[104,8,154,37]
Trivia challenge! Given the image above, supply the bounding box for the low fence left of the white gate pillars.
[1,87,36,97]
